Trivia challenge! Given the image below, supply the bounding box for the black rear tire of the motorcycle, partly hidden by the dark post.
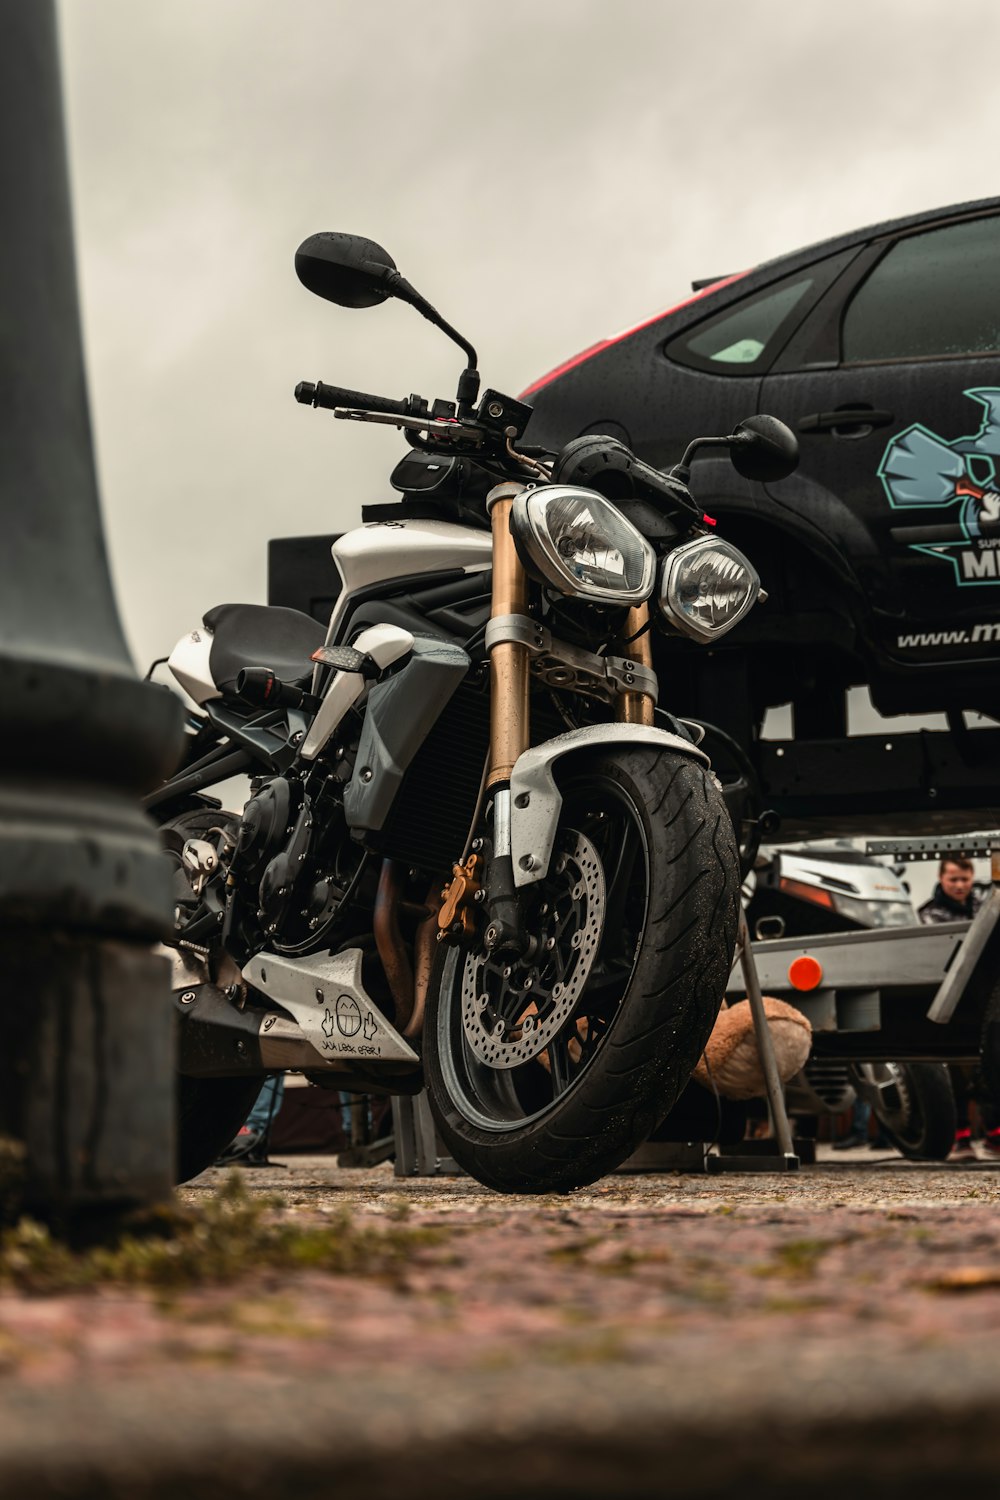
[160,806,264,1182]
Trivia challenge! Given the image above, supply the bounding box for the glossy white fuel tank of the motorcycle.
[327,521,493,641]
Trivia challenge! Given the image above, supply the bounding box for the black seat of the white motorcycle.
[202,605,327,693]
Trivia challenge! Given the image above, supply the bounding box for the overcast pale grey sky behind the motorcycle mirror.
[60,0,1000,675]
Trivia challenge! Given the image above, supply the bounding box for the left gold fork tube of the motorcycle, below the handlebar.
[487,485,531,786]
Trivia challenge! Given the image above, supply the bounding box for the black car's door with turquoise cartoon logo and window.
[760,215,1000,662]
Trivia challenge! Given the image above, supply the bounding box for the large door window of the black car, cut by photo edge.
[841,218,1000,365]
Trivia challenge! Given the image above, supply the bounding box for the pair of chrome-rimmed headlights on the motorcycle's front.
[511,485,760,641]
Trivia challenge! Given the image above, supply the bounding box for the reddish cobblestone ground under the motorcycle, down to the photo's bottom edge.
[0,1152,1000,1500]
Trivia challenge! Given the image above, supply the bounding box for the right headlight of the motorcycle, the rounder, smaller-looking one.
[660,537,760,641]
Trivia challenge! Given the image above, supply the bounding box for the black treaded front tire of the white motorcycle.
[424,749,739,1193]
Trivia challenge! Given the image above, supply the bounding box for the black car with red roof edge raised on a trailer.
[522,198,1000,836]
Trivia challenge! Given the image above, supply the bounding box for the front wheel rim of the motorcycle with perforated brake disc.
[438,780,649,1134]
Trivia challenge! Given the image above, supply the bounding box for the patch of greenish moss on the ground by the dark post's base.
[0,1172,447,1295]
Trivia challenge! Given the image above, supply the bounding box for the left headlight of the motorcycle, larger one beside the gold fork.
[511,485,657,605]
